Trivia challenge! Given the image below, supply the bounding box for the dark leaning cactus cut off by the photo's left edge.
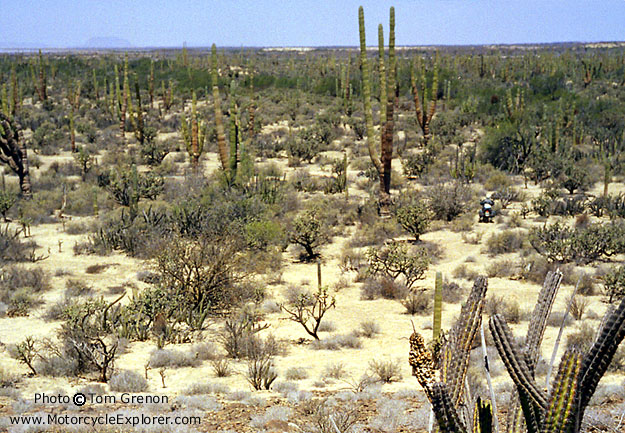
[0,113,32,198]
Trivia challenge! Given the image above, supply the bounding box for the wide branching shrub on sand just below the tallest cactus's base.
[367,242,430,289]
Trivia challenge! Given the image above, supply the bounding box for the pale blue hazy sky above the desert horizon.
[0,0,625,48]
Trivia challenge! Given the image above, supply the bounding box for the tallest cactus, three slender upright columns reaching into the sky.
[358,6,397,214]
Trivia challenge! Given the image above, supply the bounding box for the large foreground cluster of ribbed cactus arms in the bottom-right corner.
[409,272,625,433]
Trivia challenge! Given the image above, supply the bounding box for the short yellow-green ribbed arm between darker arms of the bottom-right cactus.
[541,351,582,433]
